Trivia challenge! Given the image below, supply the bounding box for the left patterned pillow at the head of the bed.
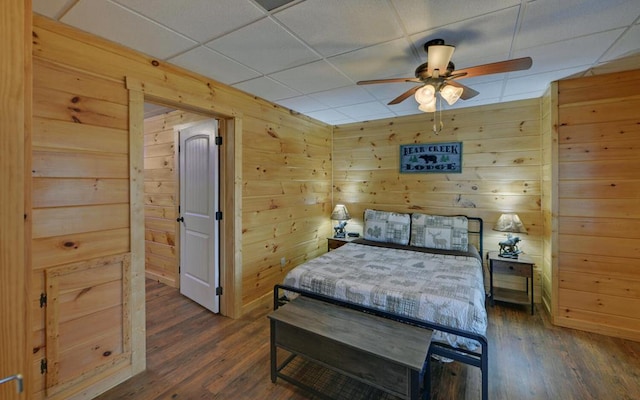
[364,209,411,245]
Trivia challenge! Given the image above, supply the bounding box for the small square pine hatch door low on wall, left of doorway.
[45,254,131,397]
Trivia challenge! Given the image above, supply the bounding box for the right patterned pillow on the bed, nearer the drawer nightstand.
[411,213,469,251]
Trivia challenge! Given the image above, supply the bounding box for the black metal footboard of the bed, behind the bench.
[273,285,489,400]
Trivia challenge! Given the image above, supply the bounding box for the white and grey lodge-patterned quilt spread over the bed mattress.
[284,243,487,350]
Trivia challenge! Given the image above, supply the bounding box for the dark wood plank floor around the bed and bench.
[98,281,640,400]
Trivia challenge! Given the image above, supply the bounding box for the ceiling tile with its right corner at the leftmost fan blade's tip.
[269,60,353,94]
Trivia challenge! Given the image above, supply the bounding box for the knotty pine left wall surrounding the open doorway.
[27,15,332,398]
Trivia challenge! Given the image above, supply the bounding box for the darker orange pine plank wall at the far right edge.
[554,70,640,340]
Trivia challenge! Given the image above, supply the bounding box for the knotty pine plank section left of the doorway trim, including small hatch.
[30,57,130,398]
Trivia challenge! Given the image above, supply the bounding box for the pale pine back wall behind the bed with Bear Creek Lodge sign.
[333,99,543,301]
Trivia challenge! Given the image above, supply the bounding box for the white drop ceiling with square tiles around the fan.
[33,0,640,125]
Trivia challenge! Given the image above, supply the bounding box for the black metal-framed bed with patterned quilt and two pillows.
[274,210,488,399]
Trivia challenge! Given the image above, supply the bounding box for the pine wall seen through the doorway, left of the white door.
[144,111,208,287]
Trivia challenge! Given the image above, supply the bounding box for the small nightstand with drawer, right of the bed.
[487,251,534,315]
